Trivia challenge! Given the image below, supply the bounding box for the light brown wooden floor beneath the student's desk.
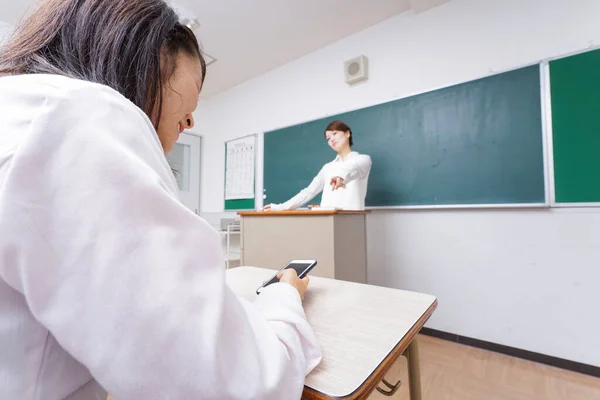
[369,335,600,400]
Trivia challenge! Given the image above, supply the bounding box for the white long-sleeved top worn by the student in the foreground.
[0,75,321,400]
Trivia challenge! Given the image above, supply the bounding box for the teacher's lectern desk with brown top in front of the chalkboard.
[238,209,367,283]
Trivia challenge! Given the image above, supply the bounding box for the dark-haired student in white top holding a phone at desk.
[0,0,321,400]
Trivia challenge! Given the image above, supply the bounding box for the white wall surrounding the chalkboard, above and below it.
[196,0,600,366]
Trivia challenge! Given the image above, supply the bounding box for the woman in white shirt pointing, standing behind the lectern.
[263,120,371,211]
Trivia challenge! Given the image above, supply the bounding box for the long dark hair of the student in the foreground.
[0,0,206,128]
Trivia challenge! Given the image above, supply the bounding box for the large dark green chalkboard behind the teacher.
[264,65,546,207]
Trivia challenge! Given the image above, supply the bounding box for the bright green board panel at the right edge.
[550,50,600,203]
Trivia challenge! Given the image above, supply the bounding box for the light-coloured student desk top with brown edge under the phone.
[227,267,437,399]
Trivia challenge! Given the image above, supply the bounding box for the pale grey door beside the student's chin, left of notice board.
[167,132,202,214]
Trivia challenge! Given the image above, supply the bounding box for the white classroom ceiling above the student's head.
[0,0,448,98]
